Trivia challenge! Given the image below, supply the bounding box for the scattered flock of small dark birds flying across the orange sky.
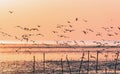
[0,11,120,46]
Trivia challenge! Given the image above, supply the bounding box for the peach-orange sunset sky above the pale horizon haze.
[0,0,120,42]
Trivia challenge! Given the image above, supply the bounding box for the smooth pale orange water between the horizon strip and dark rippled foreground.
[0,48,120,61]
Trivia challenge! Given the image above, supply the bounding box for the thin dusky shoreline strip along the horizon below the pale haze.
[0,44,120,48]
